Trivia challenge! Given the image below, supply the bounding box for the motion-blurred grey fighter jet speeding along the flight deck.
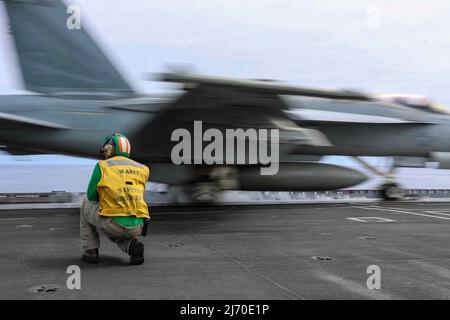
[0,0,450,201]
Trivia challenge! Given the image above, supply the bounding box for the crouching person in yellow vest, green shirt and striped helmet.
[80,133,150,265]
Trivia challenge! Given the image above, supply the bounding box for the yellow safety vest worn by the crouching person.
[97,156,150,219]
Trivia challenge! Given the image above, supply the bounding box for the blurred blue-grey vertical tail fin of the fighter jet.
[3,0,135,96]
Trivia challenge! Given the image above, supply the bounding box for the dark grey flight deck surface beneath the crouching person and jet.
[0,201,450,299]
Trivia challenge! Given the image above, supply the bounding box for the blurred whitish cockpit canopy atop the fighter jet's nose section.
[375,94,450,114]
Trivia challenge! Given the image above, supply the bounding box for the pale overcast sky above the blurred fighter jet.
[0,0,450,165]
